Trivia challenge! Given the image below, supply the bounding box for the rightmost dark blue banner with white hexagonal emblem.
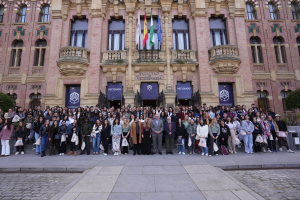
[219,83,234,106]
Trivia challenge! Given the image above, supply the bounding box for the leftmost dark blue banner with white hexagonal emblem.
[66,86,80,109]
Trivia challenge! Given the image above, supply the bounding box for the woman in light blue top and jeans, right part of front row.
[241,115,254,154]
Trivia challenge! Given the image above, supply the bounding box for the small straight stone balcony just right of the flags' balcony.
[171,49,198,64]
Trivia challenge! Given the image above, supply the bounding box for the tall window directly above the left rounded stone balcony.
[70,19,88,48]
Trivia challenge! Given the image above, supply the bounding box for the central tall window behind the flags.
[138,16,161,50]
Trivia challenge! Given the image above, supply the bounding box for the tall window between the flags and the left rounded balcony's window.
[107,19,125,51]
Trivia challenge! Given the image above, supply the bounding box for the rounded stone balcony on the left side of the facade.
[57,46,90,76]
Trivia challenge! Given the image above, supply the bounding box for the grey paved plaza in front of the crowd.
[0,151,300,200]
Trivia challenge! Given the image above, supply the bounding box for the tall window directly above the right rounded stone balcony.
[209,17,228,47]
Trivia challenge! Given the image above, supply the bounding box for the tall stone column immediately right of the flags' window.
[162,5,176,107]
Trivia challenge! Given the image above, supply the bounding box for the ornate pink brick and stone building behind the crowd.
[0,0,300,112]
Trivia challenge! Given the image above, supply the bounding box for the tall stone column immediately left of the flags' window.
[123,1,135,106]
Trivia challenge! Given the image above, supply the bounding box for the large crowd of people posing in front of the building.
[0,104,293,157]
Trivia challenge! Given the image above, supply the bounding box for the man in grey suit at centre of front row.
[150,114,164,155]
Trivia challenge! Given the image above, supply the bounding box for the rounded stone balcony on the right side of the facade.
[208,45,241,74]
